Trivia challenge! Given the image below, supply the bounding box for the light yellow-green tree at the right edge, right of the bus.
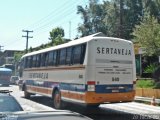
[133,15,160,56]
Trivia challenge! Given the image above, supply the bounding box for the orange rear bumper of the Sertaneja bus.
[85,91,135,104]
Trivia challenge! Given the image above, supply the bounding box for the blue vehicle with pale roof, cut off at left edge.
[0,68,12,86]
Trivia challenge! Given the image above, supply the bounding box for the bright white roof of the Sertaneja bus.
[22,32,131,58]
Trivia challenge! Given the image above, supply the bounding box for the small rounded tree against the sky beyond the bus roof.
[50,27,64,45]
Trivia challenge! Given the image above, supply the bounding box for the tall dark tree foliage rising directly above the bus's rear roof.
[77,0,143,39]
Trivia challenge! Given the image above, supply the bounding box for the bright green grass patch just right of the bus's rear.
[136,79,155,88]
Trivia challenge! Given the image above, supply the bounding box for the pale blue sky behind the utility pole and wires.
[0,0,88,51]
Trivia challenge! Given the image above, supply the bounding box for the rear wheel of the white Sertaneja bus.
[53,90,62,109]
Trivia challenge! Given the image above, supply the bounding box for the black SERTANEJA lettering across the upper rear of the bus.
[97,47,131,55]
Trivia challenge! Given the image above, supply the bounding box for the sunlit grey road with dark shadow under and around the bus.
[0,85,160,120]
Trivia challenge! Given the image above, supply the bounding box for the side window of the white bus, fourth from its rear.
[59,48,66,65]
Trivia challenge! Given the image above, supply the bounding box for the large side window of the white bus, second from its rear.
[72,45,81,64]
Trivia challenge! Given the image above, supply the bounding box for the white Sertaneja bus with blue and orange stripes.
[20,33,136,109]
